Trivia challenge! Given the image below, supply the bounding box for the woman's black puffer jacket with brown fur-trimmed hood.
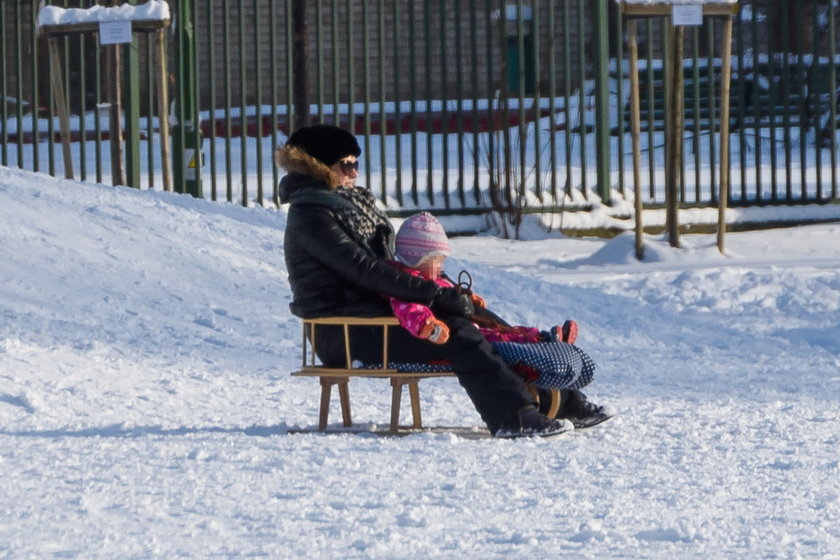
[276,146,439,318]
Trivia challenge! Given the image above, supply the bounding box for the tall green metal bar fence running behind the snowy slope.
[0,0,840,223]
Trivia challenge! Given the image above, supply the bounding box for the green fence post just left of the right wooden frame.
[595,0,611,204]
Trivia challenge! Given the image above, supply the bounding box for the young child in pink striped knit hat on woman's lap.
[391,212,595,398]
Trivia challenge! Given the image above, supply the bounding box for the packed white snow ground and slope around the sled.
[0,168,840,560]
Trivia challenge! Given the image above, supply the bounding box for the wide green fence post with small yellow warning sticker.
[172,0,203,198]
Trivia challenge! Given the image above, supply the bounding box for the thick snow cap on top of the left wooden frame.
[37,0,170,33]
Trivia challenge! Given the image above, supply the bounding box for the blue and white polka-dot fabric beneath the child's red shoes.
[493,342,595,389]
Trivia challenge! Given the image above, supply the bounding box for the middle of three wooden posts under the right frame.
[665,23,685,247]
